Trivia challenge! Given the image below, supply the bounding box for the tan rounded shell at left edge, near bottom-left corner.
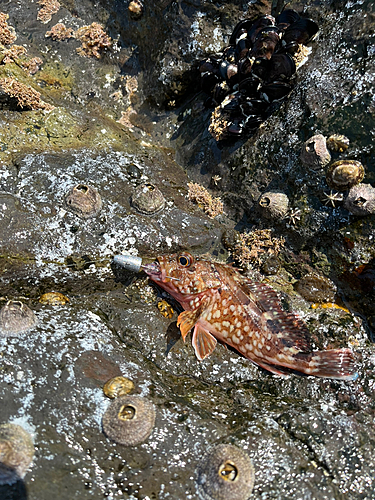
[0,424,34,485]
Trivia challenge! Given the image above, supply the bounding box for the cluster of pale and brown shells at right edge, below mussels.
[301,134,375,215]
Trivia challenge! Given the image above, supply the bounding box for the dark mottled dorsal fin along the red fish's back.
[242,281,312,352]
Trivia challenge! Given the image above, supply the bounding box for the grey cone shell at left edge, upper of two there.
[0,300,37,337]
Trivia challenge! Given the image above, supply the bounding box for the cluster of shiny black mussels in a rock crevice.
[199,9,319,140]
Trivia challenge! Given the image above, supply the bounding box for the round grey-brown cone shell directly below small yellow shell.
[102,396,155,446]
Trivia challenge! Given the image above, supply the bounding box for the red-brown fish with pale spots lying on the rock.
[142,252,358,380]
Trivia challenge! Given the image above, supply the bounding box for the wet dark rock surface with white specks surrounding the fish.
[0,0,375,500]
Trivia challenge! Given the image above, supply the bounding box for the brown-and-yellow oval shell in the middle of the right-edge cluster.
[326,160,365,191]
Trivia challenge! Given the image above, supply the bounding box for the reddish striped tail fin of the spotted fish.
[305,349,358,380]
